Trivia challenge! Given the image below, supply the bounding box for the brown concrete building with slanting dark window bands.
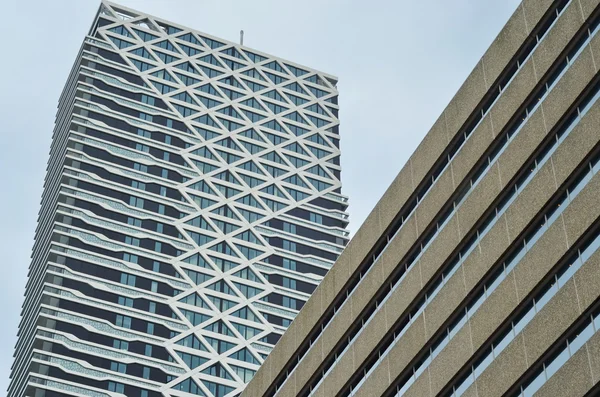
[242,0,600,397]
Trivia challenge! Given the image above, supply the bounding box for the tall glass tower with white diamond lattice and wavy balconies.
[8,2,348,397]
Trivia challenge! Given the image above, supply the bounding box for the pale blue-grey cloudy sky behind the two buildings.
[0,0,519,394]
